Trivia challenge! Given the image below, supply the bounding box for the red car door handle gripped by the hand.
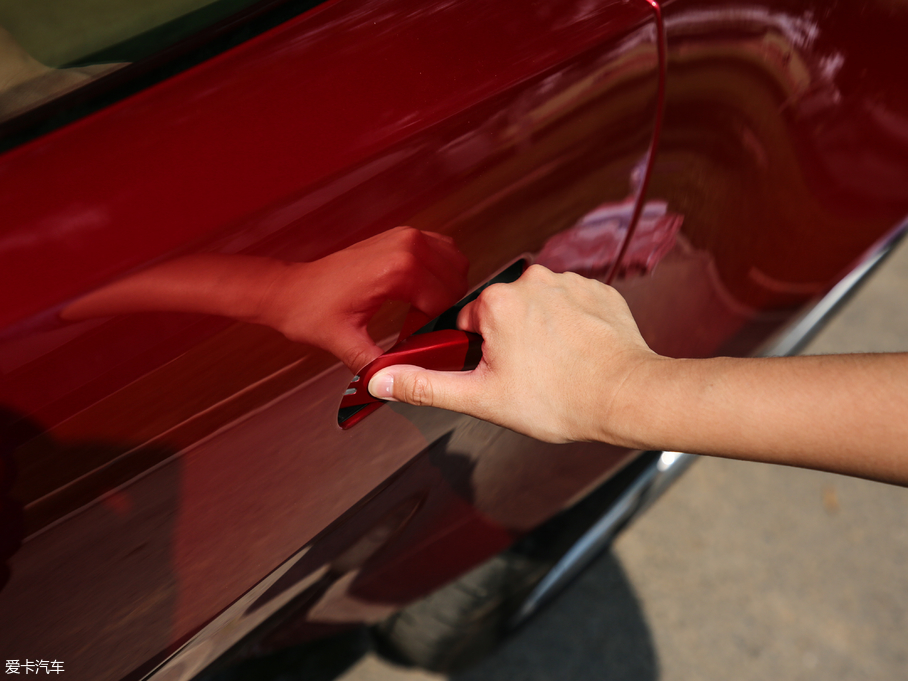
[337,329,482,430]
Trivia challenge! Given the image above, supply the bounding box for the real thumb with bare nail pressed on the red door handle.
[369,364,477,415]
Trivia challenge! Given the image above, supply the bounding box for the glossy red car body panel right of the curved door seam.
[616,0,908,357]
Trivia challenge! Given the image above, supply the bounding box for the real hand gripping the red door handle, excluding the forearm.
[369,265,663,446]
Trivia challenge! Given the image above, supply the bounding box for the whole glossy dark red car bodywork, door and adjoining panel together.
[0,0,908,679]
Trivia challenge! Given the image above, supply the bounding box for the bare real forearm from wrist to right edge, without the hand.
[612,354,908,484]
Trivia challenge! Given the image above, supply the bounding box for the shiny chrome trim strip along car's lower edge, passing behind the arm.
[509,220,908,628]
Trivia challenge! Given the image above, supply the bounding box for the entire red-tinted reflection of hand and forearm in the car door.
[61,227,468,372]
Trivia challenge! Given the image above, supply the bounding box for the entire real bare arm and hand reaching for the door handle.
[369,266,908,485]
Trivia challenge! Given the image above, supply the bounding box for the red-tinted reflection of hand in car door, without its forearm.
[258,227,469,372]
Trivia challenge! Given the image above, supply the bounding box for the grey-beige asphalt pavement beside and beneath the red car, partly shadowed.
[220,235,908,681]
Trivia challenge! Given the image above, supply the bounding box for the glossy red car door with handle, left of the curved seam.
[0,0,659,679]
